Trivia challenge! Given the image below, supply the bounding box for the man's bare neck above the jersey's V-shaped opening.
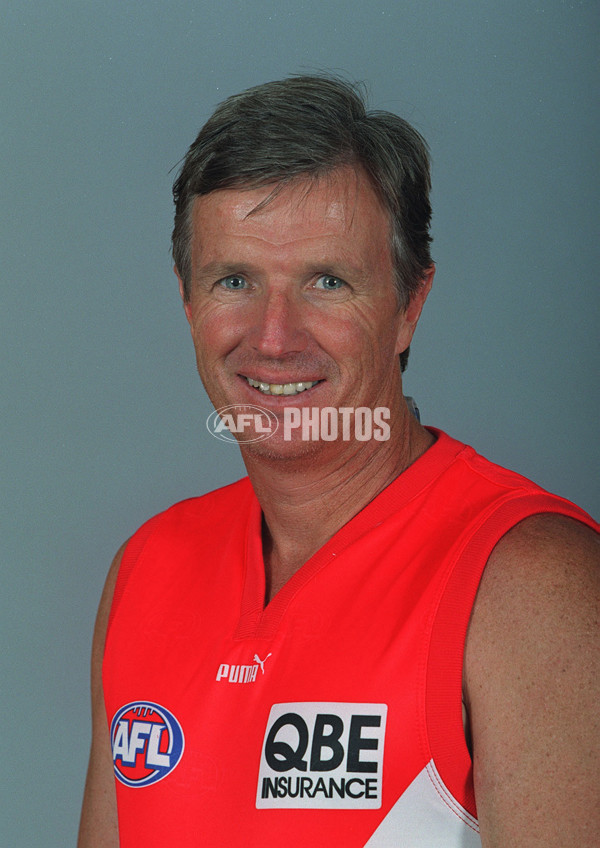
[243,407,433,602]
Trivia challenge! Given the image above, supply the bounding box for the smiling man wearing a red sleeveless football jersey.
[79,77,600,848]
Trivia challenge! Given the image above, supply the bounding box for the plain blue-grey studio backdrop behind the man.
[0,0,600,848]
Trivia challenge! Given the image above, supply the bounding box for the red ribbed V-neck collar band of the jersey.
[235,427,465,639]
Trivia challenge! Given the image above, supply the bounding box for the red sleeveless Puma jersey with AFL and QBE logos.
[103,431,593,848]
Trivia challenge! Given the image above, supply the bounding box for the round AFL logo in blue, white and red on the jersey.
[110,701,184,787]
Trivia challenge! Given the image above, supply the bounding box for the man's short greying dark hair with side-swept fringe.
[172,76,432,370]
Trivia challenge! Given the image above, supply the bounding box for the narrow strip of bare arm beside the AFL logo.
[77,543,127,848]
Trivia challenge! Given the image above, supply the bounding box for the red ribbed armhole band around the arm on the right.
[425,493,594,816]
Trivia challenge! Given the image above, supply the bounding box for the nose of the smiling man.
[250,290,307,357]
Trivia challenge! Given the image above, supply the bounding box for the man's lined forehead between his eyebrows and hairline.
[192,167,390,253]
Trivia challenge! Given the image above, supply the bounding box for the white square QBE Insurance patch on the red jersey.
[256,702,387,810]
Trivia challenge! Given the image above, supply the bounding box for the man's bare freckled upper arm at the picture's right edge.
[464,515,600,848]
